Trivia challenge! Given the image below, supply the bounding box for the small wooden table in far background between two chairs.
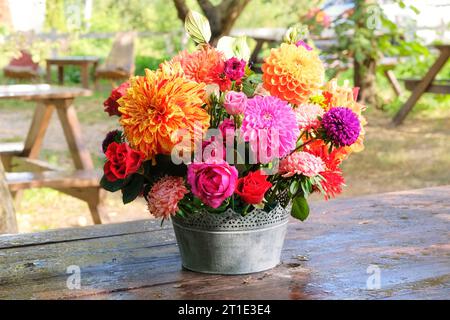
[46,56,99,89]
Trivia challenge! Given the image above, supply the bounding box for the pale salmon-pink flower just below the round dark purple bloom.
[280,151,326,178]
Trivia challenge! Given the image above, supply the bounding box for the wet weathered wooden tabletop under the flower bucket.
[0,186,450,300]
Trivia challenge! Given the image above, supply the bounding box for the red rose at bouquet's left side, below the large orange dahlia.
[103,142,144,182]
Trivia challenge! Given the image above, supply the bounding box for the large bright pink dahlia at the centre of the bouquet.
[241,96,300,163]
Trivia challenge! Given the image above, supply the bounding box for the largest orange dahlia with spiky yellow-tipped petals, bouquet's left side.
[118,63,209,159]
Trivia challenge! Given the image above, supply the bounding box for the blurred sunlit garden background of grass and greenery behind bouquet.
[0,0,450,232]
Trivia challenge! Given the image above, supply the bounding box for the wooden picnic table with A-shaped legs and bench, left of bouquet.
[0,84,104,231]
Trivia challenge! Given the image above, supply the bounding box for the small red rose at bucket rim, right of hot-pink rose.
[235,170,272,204]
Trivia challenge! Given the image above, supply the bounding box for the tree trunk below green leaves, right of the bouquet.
[353,58,377,107]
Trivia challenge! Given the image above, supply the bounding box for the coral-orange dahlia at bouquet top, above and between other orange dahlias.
[171,46,231,91]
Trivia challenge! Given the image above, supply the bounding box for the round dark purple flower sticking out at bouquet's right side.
[322,107,361,147]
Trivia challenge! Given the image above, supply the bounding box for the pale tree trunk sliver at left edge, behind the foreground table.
[0,161,17,234]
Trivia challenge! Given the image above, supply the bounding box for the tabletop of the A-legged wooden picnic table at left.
[0,84,92,100]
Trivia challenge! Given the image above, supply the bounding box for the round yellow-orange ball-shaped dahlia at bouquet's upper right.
[262,43,325,105]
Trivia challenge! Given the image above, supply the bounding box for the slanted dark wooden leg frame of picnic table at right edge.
[392,44,450,125]
